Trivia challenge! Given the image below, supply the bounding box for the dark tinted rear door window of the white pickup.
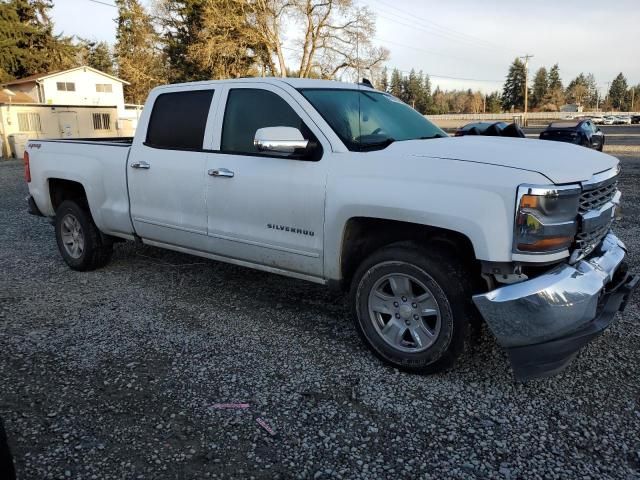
[146,90,213,150]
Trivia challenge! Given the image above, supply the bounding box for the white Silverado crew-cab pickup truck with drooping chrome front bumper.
[25,78,637,379]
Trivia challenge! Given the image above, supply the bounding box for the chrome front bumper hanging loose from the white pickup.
[473,233,639,380]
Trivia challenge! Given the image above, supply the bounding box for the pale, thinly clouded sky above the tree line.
[53,0,640,92]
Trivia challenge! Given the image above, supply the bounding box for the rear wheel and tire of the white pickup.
[55,200,113,272]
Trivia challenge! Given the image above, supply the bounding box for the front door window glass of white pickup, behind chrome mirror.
[220,88,313,154]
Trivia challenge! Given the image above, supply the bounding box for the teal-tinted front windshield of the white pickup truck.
[300,88,448,151]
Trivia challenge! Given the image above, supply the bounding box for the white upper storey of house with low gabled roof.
[3,66,129,116]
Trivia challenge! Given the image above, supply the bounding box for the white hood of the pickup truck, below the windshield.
[396,136,618,184]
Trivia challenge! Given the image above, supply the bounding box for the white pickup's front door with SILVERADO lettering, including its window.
[206,84,329,276]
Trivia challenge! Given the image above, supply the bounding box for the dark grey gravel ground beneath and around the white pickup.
[0,157,640,479]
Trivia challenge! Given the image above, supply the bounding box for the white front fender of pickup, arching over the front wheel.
[325,158,549,279]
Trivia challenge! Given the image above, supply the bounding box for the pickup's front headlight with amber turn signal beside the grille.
[513,185,582,253]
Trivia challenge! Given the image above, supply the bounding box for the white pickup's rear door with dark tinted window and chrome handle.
[127,86,215,251]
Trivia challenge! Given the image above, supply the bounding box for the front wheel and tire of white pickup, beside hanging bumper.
[350,243,475,373]
